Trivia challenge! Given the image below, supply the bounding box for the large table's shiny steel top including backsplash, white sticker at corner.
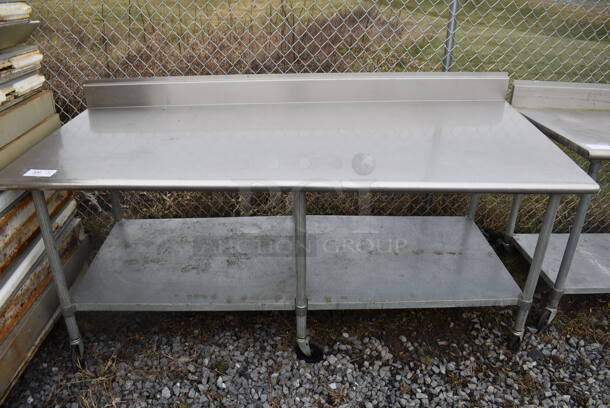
[0,74,598,193]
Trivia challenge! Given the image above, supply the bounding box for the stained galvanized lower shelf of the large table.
[73,216,521,310]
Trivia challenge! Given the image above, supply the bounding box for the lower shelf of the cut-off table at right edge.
[515,234,610,294]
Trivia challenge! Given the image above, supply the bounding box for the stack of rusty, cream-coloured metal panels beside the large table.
[0,1,88,403]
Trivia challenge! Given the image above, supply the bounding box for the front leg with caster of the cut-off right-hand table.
[538,160,601,330]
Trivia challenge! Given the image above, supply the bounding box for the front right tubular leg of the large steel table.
[510,194,561,349]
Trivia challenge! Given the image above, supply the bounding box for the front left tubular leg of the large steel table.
[32,190,84,364]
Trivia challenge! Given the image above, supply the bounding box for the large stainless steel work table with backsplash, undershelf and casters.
[0,73,598,361]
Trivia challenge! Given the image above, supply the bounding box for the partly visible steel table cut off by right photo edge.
[512,81,610,329]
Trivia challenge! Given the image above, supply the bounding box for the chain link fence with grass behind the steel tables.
[31,0,610,241]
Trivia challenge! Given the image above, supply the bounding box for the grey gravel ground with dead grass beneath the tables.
[6,296,610,408]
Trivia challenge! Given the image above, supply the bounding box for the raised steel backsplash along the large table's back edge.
[84,72,508,108]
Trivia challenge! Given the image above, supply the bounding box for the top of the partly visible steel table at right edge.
[513,81,610,160]
